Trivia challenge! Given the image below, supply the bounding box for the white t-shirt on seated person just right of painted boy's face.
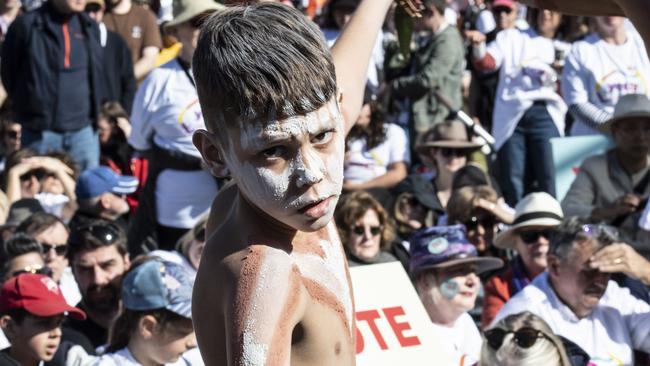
[343,123,411,183]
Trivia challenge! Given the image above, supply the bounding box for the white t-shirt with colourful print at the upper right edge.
[562,31,650,135]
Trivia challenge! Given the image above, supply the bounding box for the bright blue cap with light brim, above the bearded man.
[75,166,138,199]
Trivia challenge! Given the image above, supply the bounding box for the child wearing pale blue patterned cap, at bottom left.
[93,257,198,366]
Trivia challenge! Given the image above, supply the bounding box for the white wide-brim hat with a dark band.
[494,192,564,249]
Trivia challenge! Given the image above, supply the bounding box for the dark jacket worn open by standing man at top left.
[0,2,105,131]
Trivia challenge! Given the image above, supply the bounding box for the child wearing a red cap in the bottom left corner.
[0,273,86,366]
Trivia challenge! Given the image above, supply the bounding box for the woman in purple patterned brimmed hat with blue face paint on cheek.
[409,225,503,365]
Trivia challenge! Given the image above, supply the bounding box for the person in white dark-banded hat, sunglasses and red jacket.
[481,192,564,327]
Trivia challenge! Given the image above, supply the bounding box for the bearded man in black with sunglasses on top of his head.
[67,220,130,348]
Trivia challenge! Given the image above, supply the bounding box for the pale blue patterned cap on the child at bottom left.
[122,259,194,319]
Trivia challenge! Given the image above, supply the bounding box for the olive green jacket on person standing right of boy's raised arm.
[387,26,465,139]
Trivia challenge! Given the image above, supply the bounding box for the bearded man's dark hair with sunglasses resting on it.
[68,220,127,263]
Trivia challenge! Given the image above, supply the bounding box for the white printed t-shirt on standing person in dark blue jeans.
[487,28,567,150]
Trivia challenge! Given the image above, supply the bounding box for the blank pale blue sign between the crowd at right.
[551,134,614,202]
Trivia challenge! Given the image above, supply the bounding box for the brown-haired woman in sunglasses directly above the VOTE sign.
[334,191,397,267]
